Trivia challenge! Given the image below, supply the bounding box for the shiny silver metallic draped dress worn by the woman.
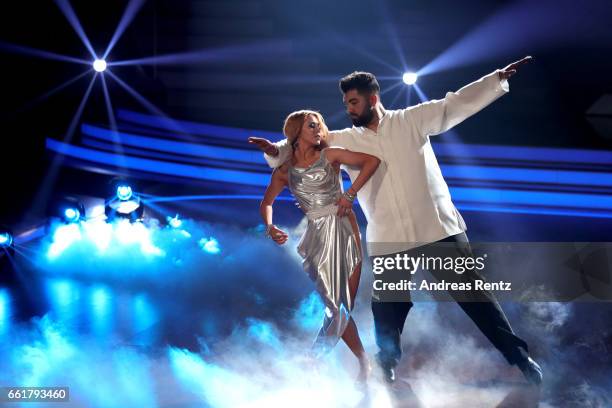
[289,150,361,352]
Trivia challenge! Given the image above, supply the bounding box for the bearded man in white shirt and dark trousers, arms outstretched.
[249,57,542,385]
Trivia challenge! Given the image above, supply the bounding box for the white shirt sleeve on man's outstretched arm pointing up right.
[403,70,510,137]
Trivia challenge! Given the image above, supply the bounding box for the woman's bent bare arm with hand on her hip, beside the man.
[325,148,380,217]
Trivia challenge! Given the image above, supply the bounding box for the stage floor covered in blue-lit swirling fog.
[0,198,612,407]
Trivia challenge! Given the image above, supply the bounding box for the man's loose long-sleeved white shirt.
[265,71,509,256]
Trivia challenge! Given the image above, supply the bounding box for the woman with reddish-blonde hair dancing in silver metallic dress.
[260,110,380,381]
